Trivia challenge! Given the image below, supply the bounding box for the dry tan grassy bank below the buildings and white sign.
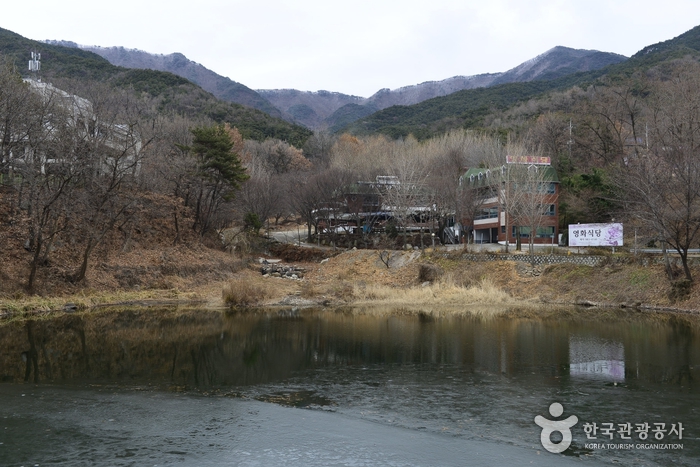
[222,250,700,312]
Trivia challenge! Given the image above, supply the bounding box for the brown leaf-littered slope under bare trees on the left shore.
[0,191,244,297]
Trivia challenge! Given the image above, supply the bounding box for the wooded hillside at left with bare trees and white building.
[0,26,312,294]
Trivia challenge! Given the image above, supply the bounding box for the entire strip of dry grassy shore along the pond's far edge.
[0,243,700,317]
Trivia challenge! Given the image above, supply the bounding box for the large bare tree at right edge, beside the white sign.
[616,63,700,281]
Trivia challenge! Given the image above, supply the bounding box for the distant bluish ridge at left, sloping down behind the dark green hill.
[45,40,282,117]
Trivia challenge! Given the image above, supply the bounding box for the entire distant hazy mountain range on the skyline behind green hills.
[53,37,626,131]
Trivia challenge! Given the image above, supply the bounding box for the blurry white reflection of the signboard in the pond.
[569,336,625,381]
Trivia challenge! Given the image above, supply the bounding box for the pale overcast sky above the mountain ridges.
[0,0,700,97]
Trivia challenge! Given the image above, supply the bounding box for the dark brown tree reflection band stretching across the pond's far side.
[0,310,700,388]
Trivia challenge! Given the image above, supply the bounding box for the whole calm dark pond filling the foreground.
[0,309,700,466]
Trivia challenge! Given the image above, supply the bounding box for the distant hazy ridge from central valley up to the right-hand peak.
[258,47,627,131]
